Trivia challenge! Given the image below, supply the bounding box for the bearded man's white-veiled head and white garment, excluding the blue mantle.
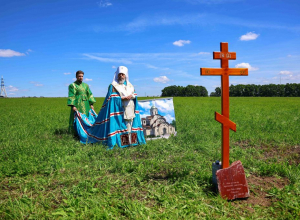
[111,66,135,143]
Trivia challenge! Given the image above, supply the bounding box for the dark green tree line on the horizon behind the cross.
[161,83,300,97]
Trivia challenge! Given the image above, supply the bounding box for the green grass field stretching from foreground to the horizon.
[0,97,300,219]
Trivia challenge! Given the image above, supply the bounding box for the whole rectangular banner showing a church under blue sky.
[139,98,176,138]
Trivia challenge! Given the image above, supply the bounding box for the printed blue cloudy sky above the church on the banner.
[138,98,175,123]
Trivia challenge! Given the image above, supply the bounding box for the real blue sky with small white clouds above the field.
[0,0,300,97]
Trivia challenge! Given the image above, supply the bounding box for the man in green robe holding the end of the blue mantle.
[68,70,96,132]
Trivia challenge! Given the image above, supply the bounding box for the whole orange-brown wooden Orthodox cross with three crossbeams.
[200,42,248,169]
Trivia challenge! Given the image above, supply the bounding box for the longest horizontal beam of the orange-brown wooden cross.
[200,68,248,76]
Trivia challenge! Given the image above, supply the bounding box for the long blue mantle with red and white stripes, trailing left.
[74,85,146,149]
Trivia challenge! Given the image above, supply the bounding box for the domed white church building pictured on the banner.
[141,106,176,137]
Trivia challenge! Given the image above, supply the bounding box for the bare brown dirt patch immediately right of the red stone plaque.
[232,175,290,212]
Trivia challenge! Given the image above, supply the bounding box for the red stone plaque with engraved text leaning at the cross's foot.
[217,160,250,200]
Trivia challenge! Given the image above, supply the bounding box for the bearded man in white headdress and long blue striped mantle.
[74,66,146,149]
